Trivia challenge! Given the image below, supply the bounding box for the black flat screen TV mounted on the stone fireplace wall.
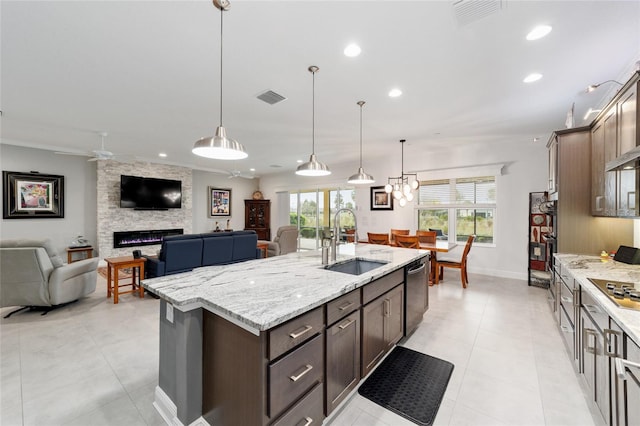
[120,175,182,210]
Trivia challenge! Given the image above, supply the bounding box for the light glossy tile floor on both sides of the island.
[0,273,600,426]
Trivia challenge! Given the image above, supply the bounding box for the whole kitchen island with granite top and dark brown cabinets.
[143,244,428,425]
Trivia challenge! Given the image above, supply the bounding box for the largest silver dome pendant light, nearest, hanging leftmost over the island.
[191,0,249,160]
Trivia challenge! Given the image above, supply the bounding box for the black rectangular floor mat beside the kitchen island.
[358,346,453,425]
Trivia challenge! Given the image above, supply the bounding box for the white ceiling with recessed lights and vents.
[0,0,640,175]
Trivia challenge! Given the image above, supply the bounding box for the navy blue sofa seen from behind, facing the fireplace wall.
[145,231,262,278]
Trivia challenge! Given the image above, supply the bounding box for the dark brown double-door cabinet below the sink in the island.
[362,285,404,376]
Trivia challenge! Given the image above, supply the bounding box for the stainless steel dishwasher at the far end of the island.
[404,256,429,336]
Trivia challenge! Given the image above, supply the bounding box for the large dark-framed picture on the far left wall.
[2,170,64,219]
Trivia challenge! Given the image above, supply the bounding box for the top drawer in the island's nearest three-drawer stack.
[269,307,324,361]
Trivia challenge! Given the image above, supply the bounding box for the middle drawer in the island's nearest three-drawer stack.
[269,334,324,417]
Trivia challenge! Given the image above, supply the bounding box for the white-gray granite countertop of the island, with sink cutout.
[142,244,428,334]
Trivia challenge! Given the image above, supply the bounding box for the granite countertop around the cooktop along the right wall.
[554,254,640,344]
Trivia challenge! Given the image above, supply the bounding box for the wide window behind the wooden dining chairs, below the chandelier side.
[418,176,496,244]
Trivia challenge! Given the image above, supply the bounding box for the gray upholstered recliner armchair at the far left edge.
[0,239,99,315]
